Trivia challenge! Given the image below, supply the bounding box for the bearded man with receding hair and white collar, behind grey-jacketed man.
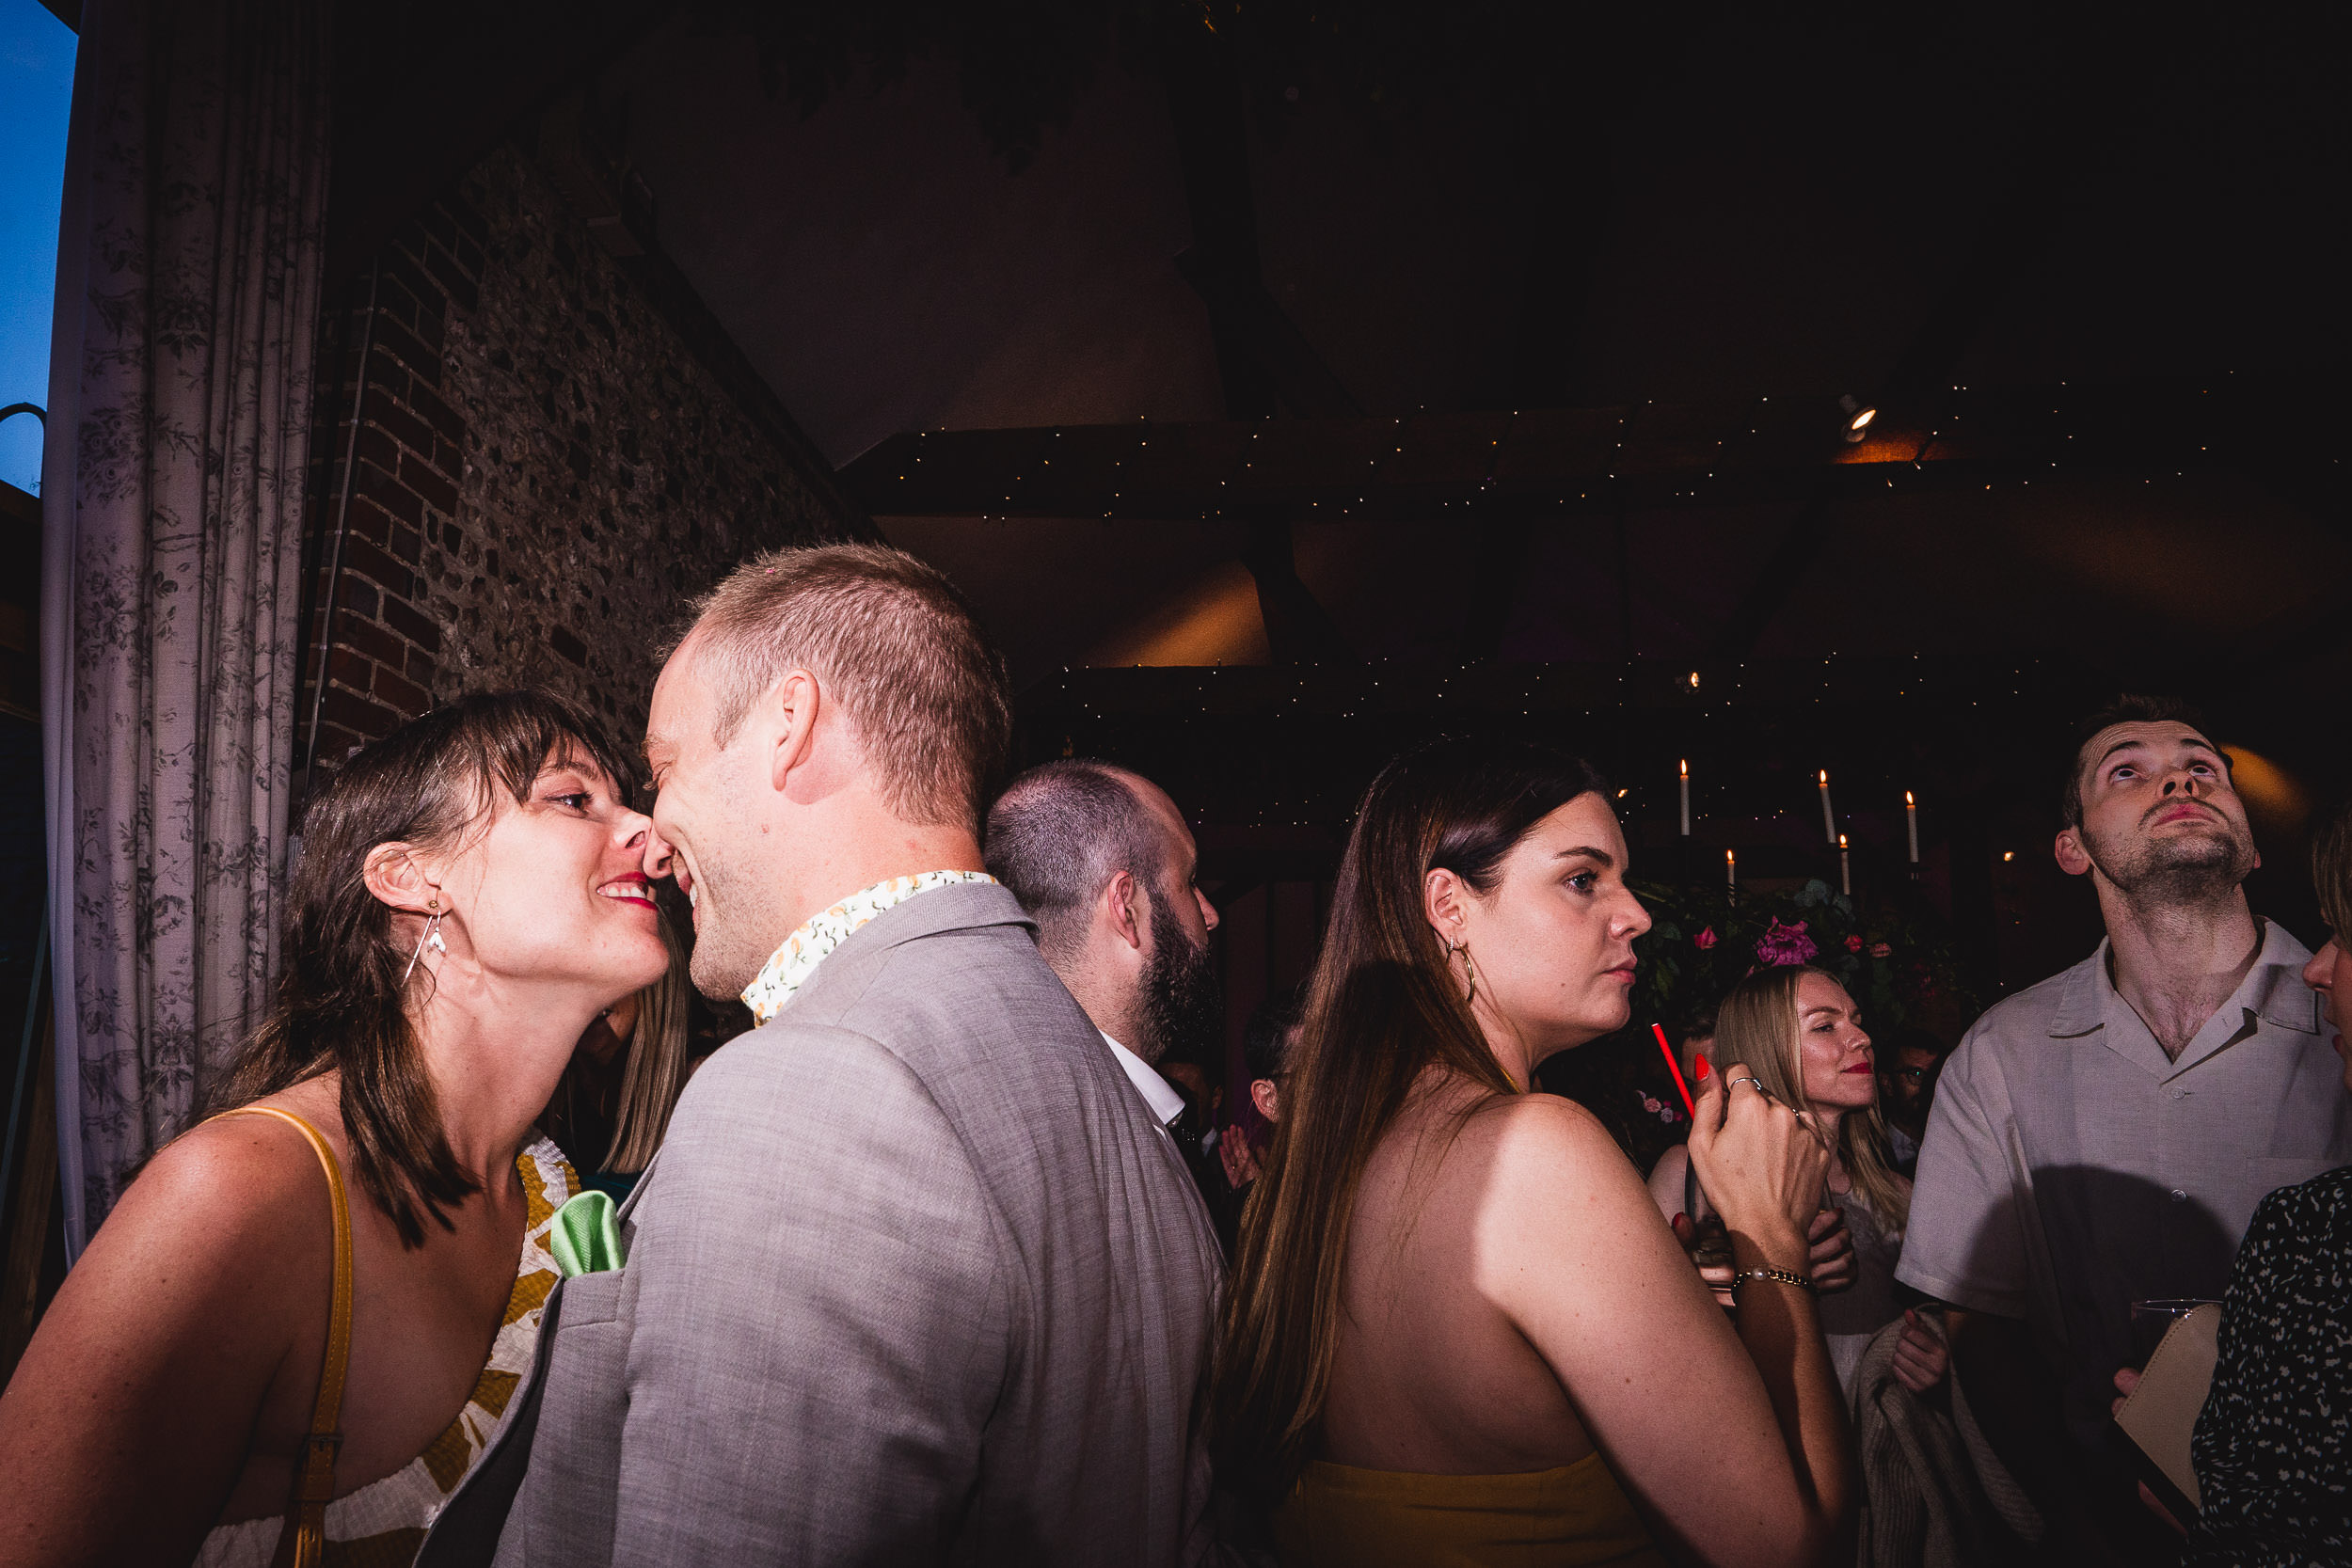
[983,757,1226,1218]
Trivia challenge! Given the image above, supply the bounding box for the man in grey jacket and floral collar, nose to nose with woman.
[421,546,1221,1568]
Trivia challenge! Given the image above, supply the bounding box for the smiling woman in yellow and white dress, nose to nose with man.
[0,693,668,1568]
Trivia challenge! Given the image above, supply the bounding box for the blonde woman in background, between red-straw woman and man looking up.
[1649,964,1947,1397]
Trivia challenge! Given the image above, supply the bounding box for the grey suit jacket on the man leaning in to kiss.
[419,884,1221,1568]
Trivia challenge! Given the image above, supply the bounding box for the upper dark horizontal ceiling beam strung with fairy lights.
[842,373,2352,526]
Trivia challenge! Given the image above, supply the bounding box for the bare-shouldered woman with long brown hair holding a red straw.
[1214,740,1853,1568]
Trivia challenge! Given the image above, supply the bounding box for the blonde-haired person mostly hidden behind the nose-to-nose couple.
[539,914,691,1204]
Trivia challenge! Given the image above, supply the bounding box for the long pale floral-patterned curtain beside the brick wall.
[42,0,329,1253]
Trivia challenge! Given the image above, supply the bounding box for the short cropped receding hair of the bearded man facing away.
[981,757,1165,959]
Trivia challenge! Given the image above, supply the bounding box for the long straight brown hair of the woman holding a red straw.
[1212,738,1602,1500]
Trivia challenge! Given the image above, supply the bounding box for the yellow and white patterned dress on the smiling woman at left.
[196,1138,579,1568]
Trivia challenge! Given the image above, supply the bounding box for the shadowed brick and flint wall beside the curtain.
[294,143,859,768]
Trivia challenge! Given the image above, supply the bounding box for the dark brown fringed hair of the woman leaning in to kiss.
[207,691,633,1246]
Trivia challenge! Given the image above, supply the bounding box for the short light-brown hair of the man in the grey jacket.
[690,546,1014,828]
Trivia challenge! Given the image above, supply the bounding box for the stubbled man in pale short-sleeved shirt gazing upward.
[1896,698,2352,1563]
